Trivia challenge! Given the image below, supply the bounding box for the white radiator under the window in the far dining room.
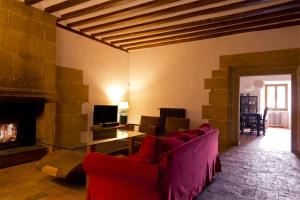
[267,111,289,127]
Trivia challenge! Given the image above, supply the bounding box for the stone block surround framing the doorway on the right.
[202,49,300,152]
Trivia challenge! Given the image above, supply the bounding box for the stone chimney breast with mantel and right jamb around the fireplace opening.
[0,0,56,148]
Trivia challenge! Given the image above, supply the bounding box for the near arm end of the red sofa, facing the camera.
[83,153,159,200]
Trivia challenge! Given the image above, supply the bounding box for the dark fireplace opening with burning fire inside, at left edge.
[0,102,44,150]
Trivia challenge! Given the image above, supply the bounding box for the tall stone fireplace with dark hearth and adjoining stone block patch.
[0,0,89,168]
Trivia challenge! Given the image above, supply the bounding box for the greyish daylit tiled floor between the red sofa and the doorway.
[197,147,300,200]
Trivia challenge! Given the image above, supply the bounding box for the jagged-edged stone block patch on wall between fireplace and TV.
[55,66,89,148]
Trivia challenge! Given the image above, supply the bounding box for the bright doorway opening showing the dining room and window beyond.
[239,75,292,151]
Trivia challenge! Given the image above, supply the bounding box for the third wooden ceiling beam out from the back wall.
[110,9,300,45]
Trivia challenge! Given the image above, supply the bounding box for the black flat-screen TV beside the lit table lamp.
[94,105,118,124]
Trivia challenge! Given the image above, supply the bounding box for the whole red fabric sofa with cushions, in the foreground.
[83,124,221,200]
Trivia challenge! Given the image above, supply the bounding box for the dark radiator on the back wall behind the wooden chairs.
[159,108,185,135]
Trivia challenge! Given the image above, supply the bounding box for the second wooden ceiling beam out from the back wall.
[119,13,300,49]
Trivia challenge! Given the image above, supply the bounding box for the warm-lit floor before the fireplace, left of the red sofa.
[0,162,85,200]
